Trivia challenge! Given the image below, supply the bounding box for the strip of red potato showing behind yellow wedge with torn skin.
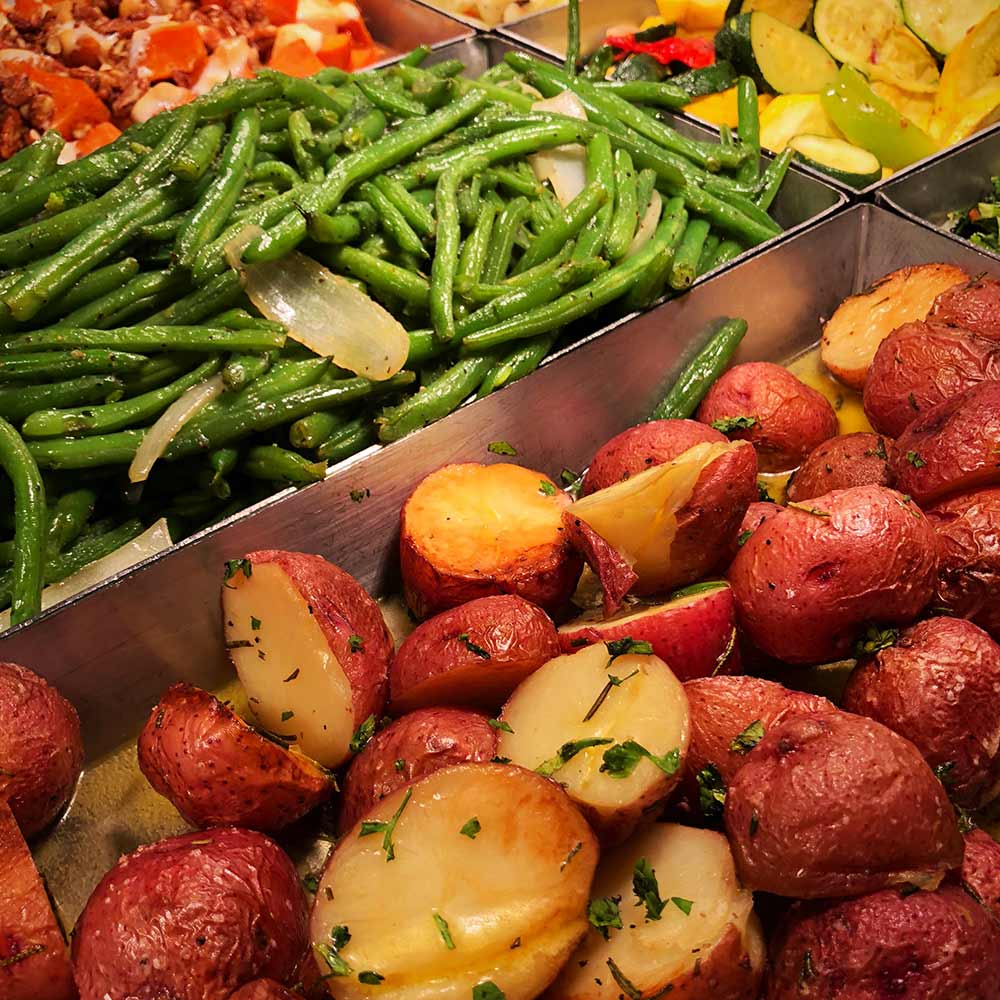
[582,420,726,496]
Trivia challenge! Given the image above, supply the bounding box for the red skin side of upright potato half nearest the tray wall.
[246,549,393,724]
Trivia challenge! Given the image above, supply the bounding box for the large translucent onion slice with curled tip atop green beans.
[226,226,410,381]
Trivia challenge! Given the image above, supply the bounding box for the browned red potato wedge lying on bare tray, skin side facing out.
[139,684,336,833]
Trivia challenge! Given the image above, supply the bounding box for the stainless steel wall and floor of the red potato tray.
[0,205,1000,925]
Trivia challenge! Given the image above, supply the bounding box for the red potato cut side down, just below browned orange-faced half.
[389,594,559,715]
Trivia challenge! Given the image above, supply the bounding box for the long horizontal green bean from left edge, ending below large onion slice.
[0,326,285,356]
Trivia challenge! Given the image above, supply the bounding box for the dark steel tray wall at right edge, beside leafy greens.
[878,125,1000,253]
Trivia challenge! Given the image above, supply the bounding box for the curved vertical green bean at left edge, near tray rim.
[0,418,48,625]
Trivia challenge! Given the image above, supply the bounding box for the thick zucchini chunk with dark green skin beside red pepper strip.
[715,11,837,94]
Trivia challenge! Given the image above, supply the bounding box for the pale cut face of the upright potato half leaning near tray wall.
[222,564,356,767]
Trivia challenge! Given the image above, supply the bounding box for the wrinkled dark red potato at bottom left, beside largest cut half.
[73,827,309,1000]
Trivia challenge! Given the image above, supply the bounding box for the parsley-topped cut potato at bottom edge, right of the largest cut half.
[545,823,765,1000]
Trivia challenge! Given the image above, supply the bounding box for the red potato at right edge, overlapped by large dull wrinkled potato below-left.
[842,618,1000,809]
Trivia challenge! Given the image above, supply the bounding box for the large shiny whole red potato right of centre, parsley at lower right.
[729,486,937,664]
